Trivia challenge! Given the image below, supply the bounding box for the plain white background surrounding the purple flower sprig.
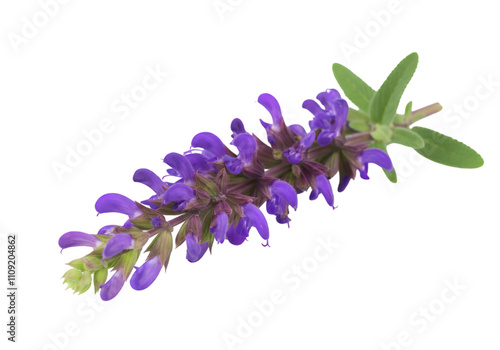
[0,0,500,350]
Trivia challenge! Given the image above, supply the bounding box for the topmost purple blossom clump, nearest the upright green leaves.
[302,89,349,146]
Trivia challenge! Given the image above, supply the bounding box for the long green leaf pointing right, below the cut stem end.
[412,126,484,169]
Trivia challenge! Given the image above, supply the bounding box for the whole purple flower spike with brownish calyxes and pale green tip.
[59,89,392,300]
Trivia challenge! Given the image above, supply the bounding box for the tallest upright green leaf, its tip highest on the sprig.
[370,52,418,125]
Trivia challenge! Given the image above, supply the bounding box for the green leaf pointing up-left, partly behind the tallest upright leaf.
[332,63,375,112]
